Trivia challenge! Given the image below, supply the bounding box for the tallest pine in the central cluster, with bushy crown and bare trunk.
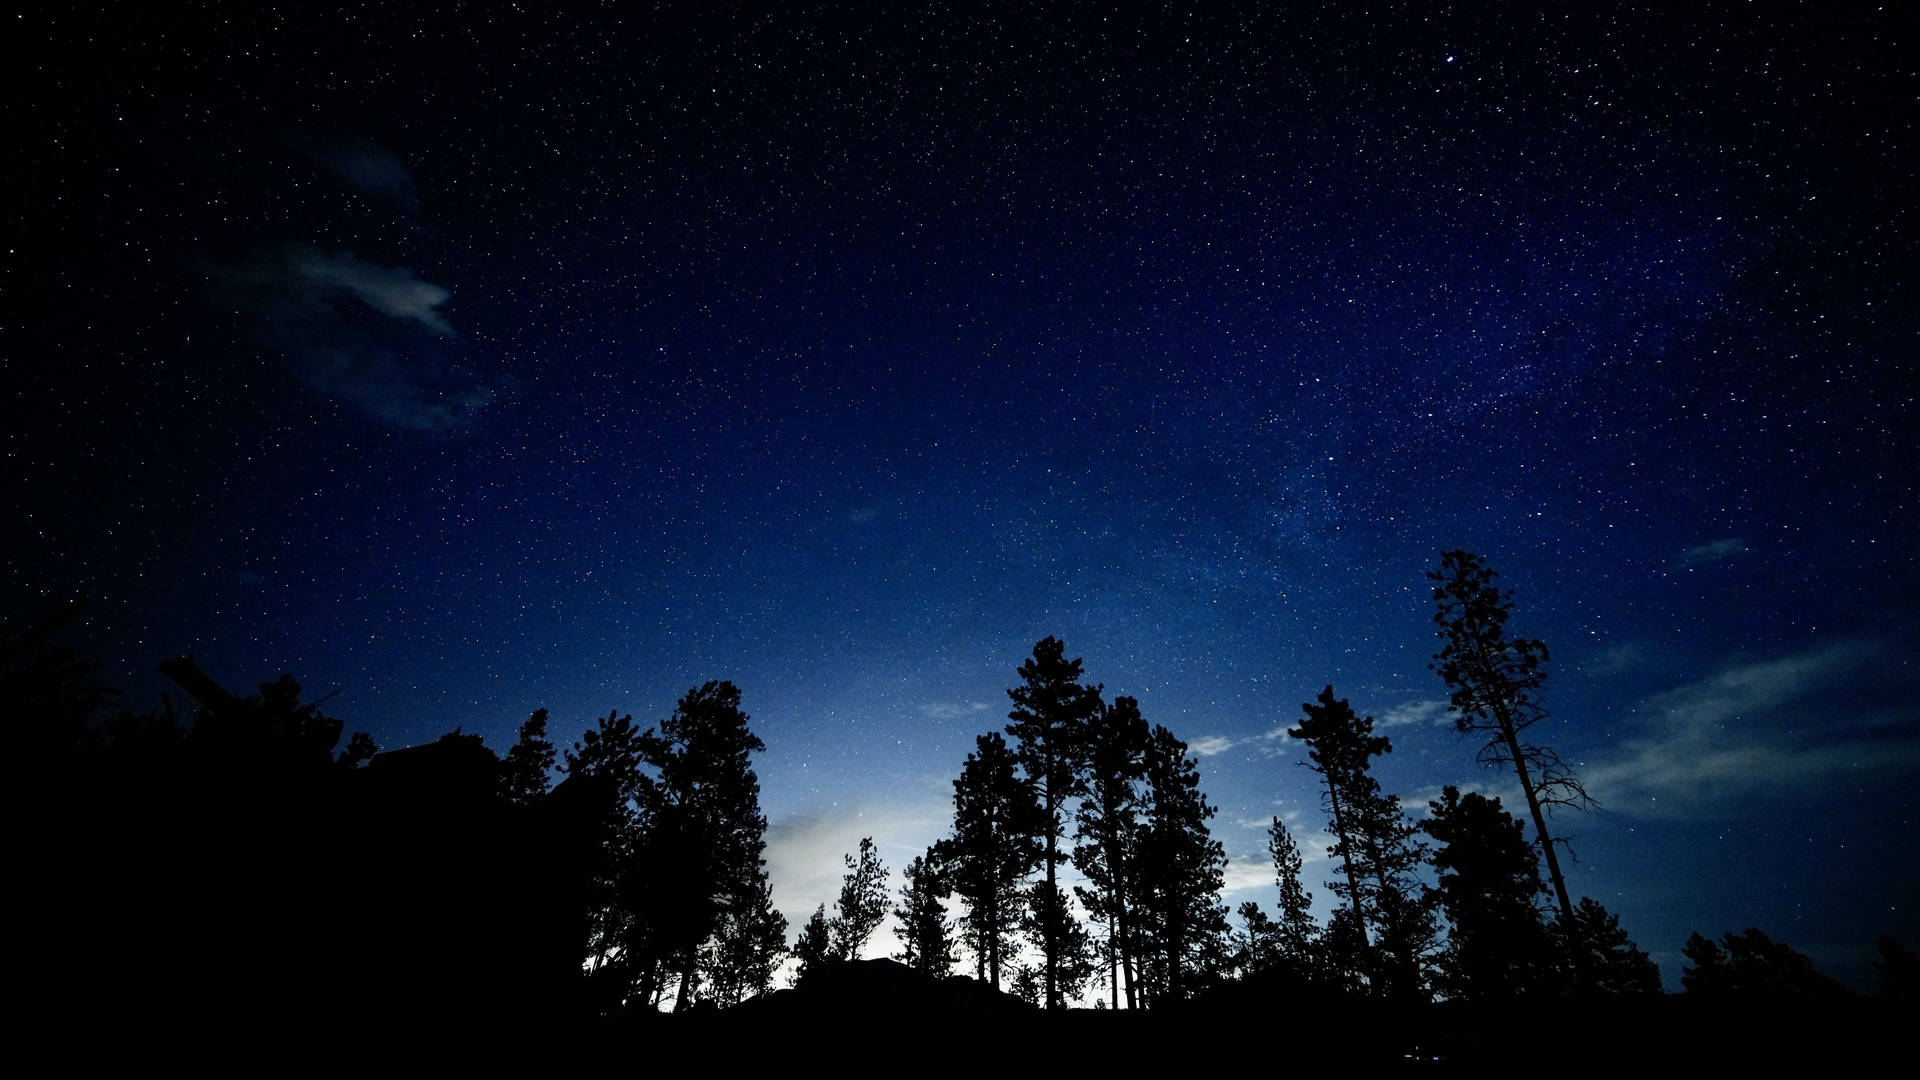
[1006,638,1100,1009]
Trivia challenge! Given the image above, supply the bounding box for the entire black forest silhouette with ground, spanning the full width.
[11,552,1916,1067]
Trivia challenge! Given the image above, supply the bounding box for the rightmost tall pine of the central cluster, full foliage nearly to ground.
[1139,726,1227,1001]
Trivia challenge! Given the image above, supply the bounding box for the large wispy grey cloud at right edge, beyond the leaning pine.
[1582,642,1920,815]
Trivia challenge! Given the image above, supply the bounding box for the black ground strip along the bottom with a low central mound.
[48,961,1914,1076]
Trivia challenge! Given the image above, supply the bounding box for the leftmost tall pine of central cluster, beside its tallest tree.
[935,732,1043,990]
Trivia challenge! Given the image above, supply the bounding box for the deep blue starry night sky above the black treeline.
[0,2,1920,988]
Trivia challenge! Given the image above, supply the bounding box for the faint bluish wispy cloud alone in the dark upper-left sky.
[215,246,507,430]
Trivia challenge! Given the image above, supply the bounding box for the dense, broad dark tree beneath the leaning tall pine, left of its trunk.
[1421,786,1555,1001]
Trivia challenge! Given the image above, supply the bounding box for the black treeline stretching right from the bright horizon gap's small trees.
[775,552,1914,1009]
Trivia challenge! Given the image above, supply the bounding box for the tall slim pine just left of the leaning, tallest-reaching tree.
[1286,686,1434,999]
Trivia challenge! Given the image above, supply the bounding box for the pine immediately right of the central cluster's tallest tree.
[1073,698,1152,1009]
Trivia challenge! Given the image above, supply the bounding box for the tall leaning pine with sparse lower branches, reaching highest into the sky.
[1427,552,1592,928]
